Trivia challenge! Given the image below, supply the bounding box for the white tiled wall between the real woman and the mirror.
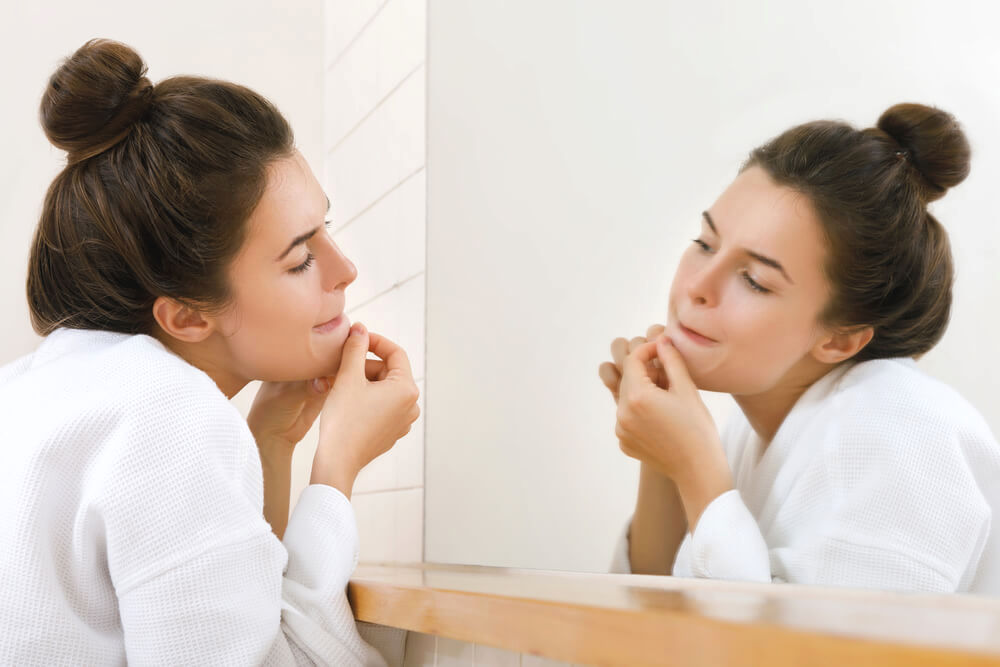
[324,0,584,667]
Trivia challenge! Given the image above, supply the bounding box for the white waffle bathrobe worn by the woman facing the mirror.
[0,329,398,666]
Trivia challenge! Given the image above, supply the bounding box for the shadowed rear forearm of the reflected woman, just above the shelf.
[629,463,687,574]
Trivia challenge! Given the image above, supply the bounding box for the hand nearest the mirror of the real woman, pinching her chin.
[310,323,420,498]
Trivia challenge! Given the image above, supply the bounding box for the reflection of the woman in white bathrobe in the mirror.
[600,104,1000,594]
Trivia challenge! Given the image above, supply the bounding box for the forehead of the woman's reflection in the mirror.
[710,167,826,278]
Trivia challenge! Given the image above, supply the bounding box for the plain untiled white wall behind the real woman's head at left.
[0,0,323,364]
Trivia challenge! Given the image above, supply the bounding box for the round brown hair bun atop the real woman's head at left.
[39,39,153,163]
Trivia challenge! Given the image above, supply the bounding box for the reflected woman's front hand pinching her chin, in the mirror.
[615,336,733,531]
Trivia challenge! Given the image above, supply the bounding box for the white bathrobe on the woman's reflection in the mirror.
[612,359,1000,595]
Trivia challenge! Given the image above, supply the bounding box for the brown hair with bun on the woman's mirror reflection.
[743,104,970,361]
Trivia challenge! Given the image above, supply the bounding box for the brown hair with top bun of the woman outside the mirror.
[27,39,294,335]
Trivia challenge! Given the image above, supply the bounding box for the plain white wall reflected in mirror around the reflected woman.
[425,0,1000,571]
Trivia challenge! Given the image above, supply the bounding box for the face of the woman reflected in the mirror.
[667,167,830,395]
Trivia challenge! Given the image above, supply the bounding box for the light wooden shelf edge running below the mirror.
[348,566,1000,667]
